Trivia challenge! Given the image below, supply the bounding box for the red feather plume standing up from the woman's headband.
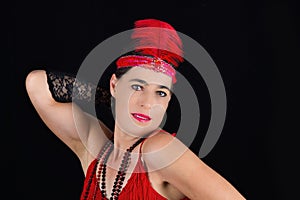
[131,19,183,67]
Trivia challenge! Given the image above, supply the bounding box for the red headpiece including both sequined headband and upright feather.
[116,19,183,83]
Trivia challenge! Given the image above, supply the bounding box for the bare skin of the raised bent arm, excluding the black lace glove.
[26,70,104,159]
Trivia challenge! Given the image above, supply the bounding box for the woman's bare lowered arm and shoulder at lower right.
[144,133,244,200]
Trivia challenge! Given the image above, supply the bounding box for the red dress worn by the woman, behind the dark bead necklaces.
[80,138,188,200]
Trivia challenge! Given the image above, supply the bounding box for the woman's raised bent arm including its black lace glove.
[26,70,108,171]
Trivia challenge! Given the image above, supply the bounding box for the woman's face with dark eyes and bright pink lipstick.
[110,67,172,137]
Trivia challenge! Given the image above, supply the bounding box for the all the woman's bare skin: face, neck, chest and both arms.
[26,67,245,200]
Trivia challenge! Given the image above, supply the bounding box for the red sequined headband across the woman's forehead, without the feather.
[116,55,176,84]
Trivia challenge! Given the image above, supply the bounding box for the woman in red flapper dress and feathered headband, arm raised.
[26,19,244,199]
